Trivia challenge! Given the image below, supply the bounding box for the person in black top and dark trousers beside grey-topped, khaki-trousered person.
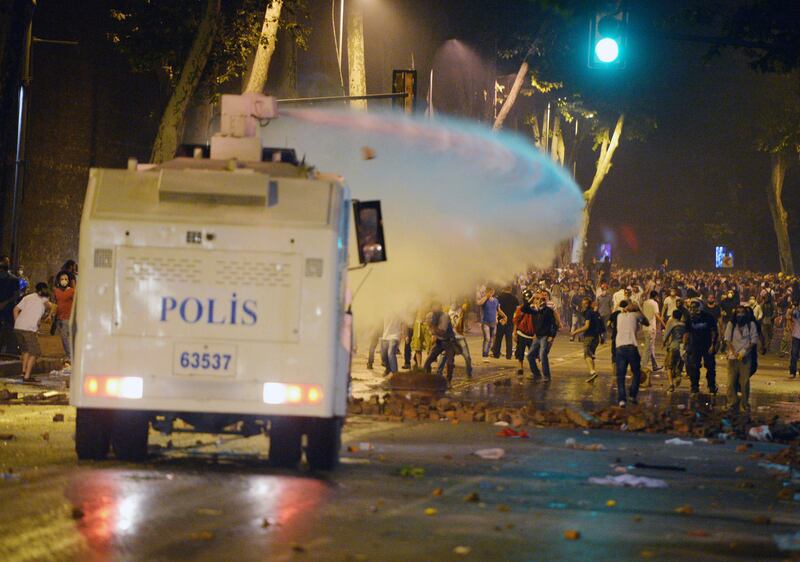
[683,299,719,395]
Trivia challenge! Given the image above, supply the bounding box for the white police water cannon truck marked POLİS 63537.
[70,94,386,470]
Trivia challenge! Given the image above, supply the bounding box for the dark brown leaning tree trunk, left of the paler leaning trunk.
[150,0,219,164]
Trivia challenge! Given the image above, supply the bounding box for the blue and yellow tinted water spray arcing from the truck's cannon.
[262,109,583,329]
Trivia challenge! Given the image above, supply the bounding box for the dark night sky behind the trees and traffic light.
[2,0,800,278]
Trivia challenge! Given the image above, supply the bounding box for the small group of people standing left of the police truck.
[0,256,78,382]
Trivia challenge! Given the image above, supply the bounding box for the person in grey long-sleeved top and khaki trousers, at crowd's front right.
[725,306,758,415]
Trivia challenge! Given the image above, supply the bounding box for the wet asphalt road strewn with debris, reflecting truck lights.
[0,338,800,561]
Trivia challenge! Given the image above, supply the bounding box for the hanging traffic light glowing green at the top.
[589,0,628,68]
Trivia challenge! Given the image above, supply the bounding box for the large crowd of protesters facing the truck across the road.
[369,260,800,412]
